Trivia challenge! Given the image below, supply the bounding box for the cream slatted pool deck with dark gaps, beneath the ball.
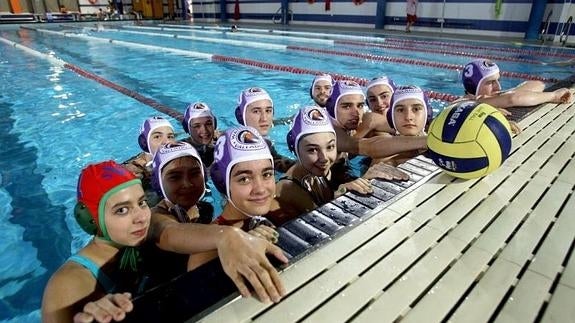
[194,93,575,322]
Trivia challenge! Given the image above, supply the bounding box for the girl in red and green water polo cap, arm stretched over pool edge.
[42,161,287,322]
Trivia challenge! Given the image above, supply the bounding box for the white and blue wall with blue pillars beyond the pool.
[192,0,575,42]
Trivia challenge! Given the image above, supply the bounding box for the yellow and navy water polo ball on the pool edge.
[427,101,511,179]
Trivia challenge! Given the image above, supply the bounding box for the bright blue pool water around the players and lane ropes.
[0,25,573,322]
